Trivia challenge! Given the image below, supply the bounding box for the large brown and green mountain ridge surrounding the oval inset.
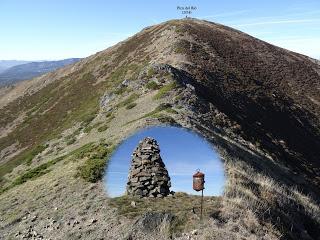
[0,19,320,239]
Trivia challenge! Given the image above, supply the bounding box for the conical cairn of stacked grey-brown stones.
[127,137,173,197]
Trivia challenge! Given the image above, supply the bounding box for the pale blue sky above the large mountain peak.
[0,0,320,60]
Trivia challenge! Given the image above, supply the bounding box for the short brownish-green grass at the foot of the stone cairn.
[110,192,221,235]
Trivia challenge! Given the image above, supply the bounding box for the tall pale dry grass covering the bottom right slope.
[220,160,320,239]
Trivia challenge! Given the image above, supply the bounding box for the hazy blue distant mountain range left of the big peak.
[0,58,81,86]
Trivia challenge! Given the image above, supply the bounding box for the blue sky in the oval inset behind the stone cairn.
[104,127,225,197]
